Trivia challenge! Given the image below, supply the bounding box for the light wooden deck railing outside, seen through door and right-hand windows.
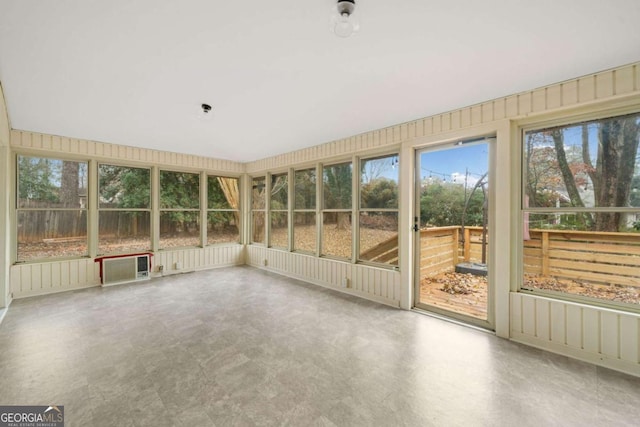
[361,226,640,286]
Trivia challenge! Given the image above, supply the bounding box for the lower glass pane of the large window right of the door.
[522,213,640,304]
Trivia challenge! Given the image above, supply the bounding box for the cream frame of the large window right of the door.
[512,106,640,313]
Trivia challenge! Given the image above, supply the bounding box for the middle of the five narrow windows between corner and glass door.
[293,169,317,254]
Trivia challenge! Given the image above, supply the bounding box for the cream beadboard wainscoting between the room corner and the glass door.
[246,245,400,307]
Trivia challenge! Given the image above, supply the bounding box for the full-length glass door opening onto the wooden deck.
[414,137,494,328]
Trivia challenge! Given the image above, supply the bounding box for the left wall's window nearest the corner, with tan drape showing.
[207,176,240,245]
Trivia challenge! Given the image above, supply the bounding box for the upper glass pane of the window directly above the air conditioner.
[98,165,151,209]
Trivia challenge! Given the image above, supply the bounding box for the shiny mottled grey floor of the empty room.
[0,267,640,427]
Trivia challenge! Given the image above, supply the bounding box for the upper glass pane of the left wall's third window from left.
[160,171,200,209]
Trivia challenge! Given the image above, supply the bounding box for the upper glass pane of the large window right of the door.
[523,114,640,214]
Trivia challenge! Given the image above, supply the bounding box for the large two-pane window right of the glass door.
[521,114,640,305]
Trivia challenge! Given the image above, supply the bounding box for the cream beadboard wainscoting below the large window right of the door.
[511,293,640,376]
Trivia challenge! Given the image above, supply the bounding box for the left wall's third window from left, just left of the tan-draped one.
[160,171,200,249]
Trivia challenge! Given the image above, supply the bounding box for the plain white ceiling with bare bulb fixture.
[0,0,640,161]
